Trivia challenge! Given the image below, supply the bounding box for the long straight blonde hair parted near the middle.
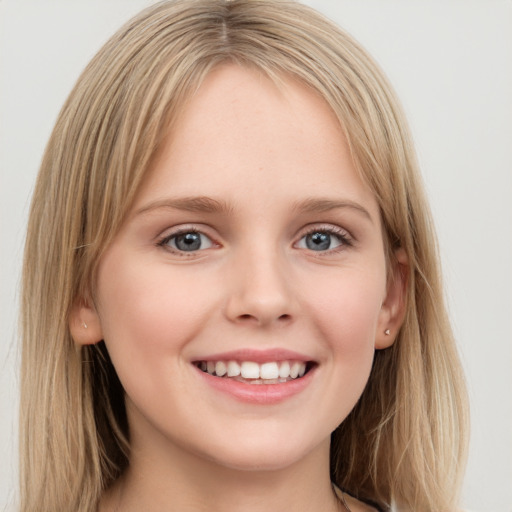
[20,0,467,512]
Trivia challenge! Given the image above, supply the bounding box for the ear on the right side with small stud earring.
[375,248,409,350]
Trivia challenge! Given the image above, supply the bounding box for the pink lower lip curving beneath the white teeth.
[196,367,316,405]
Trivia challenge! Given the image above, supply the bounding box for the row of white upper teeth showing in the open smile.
[198,361,306,384]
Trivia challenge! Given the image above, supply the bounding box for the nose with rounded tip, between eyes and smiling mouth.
[226,251,296,327]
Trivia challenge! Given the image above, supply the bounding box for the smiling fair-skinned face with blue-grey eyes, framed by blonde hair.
[74,65,406,468]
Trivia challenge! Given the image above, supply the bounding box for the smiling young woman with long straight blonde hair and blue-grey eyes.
[21,0,466,512]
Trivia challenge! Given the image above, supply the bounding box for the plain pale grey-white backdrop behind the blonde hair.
[0,0,512,512]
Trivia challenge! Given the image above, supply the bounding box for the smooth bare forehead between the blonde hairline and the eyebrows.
[134,64,376,216]
